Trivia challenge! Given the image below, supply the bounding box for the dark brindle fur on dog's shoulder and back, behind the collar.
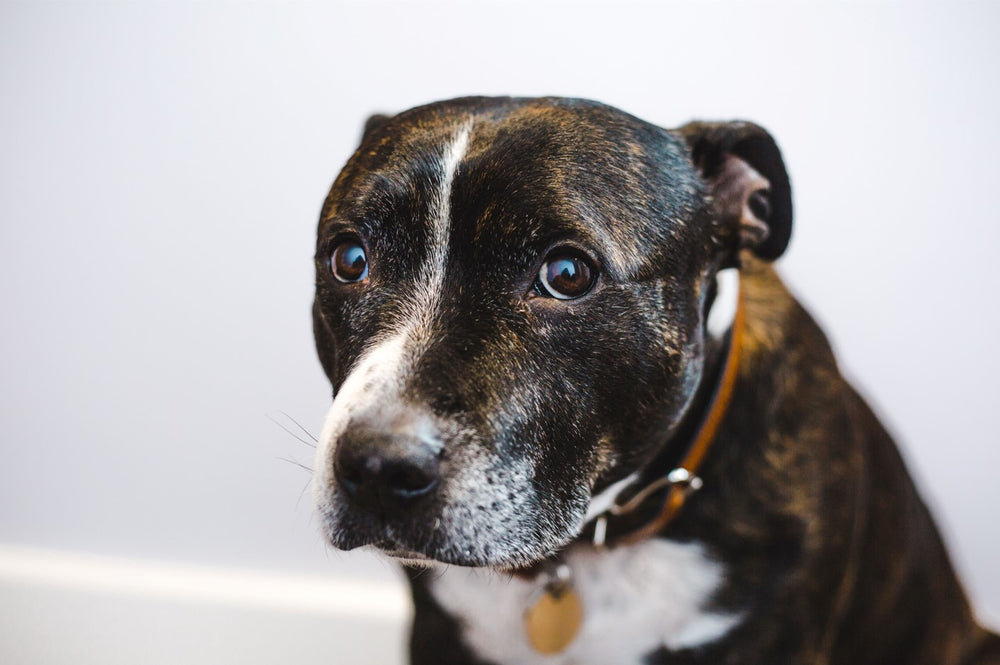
[671,255,1000,665]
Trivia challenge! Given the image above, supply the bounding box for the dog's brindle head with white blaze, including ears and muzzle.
[313,98,791,568]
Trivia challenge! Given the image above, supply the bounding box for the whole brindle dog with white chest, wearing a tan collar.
[313,98,1000,665]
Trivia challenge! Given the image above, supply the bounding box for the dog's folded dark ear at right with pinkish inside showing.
[678,122,792,261]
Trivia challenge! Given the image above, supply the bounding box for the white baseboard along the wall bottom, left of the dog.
[0,547,409,665]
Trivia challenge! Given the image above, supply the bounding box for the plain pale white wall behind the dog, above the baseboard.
[0,1,1000,653]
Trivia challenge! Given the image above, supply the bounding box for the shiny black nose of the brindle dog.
[333,428,438,505]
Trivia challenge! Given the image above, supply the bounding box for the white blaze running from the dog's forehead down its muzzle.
[315,121,472,497]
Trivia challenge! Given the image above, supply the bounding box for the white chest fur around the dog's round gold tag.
[428,539,739,665]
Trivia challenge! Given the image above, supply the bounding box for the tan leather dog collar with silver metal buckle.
[587,269,745,547]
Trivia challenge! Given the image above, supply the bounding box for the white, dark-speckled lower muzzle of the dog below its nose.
[314,434,590,569]
